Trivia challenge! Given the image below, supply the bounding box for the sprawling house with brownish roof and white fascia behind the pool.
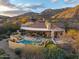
[21,20,65,42]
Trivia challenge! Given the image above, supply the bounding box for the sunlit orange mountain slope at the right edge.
[52,5,79,19]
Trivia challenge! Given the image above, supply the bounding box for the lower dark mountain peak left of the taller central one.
[11,12,42,20]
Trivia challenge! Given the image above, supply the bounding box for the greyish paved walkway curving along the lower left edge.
[0,39,17,59]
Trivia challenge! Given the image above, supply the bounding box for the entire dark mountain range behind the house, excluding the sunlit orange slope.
[12,8,68,20]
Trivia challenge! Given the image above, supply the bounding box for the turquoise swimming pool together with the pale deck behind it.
[17,36,44,44]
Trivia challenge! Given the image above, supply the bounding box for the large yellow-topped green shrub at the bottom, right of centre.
[45,44,66,59]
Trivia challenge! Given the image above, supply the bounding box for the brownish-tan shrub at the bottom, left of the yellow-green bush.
[24,45,44,59]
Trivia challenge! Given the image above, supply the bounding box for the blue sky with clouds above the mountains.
[0,0,79,16]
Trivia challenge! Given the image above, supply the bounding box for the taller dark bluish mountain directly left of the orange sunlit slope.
[41,8,68,18]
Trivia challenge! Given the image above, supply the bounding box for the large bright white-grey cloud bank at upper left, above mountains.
[0,0,42,17]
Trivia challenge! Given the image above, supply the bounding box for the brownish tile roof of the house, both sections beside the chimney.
[20,20,62,31]
